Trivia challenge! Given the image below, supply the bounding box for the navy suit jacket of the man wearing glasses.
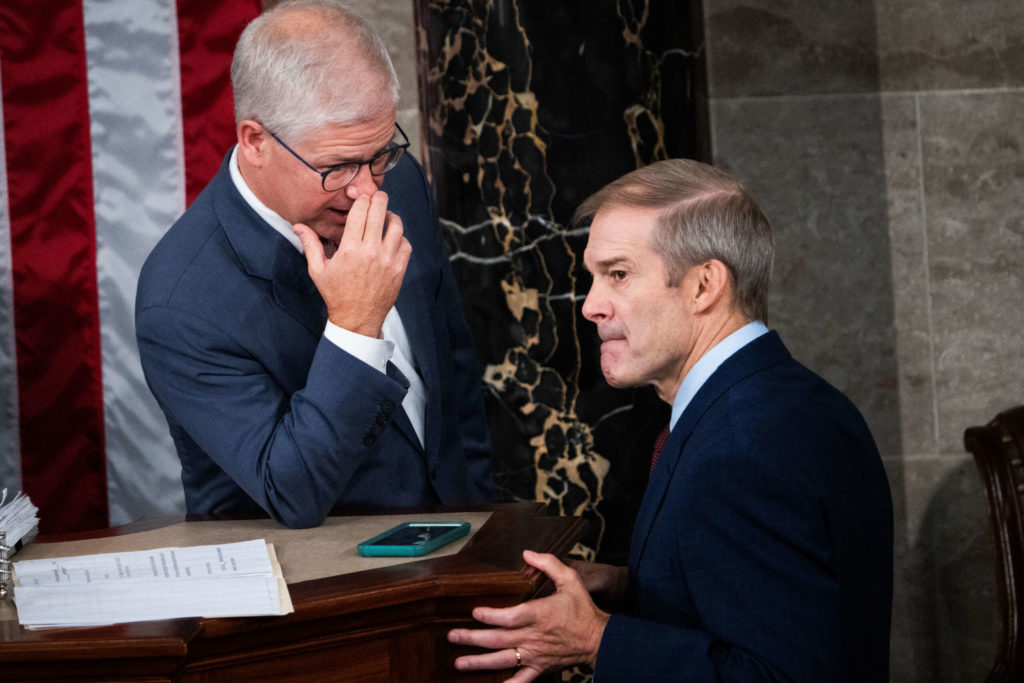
[135,155,493,526]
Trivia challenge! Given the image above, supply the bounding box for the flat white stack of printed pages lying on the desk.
[14,540,294,627]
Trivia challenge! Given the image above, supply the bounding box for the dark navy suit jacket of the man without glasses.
[595,332,893,683]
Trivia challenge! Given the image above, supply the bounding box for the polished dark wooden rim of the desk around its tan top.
[0,503,586,673]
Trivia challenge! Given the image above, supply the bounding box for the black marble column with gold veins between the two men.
[416,0,708,561]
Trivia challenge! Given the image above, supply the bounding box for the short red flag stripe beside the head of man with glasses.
[177,0,262,204]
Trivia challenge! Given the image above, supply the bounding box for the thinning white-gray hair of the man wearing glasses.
[231,0,399,140]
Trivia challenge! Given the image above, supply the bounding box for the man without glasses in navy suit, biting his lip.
[449,159,893,683]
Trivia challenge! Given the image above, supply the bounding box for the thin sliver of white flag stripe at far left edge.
[0,61,22,492]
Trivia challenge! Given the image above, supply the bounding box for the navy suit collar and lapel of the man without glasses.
[630,332,792,581]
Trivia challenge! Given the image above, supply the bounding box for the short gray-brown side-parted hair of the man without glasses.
[572,159,775,323]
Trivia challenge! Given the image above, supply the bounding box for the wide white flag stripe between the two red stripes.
[83,0,185,524]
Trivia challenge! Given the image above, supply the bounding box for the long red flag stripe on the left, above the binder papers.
[0,0,108,532]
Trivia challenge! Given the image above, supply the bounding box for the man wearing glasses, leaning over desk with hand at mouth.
[135,0,493,527]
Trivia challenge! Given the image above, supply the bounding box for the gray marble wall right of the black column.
[705,0,1024,682]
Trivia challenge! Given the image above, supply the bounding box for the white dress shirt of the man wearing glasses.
[228,145,427,445]
